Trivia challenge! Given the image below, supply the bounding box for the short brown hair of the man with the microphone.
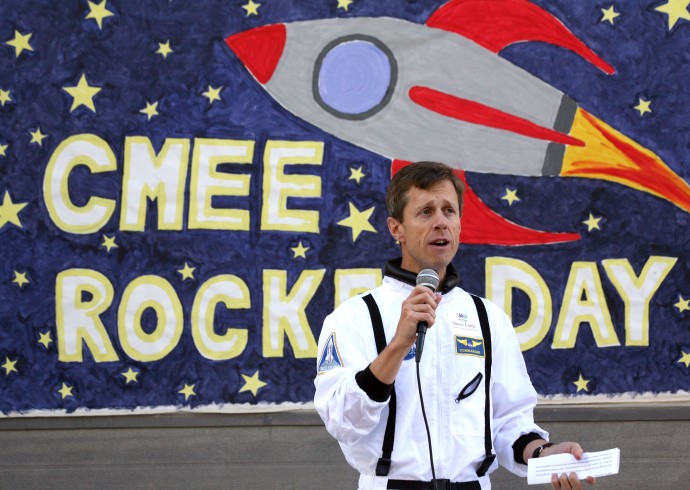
[386,162,465,223]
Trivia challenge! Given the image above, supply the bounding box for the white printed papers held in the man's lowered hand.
[527,448,621,485]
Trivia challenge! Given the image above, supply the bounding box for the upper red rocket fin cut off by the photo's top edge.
[426,0,616,75]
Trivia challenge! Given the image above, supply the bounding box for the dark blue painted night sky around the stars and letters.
[0,0,690,413]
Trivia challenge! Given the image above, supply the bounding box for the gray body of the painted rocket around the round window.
[265,17,577,176]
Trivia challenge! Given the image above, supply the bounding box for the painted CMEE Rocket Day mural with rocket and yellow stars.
[0,0,690,415]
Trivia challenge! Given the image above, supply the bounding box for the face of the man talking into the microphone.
[388,180,460,279]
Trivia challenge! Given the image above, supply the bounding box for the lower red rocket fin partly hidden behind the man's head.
[391,160,580,246]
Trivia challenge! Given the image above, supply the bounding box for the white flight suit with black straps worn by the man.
[314,275,548,489]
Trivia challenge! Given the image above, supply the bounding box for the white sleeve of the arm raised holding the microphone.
[314,297,388,445]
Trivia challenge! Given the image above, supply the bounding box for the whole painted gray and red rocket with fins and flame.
[226,0,690,245]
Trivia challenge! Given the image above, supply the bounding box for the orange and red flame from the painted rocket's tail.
[560,109,690,213]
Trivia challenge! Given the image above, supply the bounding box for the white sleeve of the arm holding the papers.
[487,302,549,476]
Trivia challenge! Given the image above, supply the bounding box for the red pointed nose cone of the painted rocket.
[225,24,286,84]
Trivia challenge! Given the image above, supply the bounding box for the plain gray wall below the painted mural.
[0,404,690,490]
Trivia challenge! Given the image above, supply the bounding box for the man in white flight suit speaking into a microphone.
[314,162,594,490]
